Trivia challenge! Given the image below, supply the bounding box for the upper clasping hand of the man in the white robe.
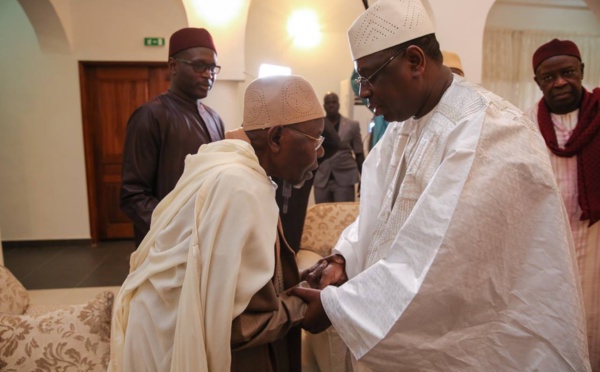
[300,254,348,289]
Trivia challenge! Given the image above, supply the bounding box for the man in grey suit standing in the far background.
[314,92,365,203]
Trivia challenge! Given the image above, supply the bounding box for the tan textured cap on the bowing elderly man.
[242,75,325,131]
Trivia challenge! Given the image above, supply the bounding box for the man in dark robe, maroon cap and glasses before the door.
[120,28,224,246]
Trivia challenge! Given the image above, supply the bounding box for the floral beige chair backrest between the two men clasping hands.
[300,202,358,257]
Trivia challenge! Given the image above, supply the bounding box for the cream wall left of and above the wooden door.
[0,0,187,241]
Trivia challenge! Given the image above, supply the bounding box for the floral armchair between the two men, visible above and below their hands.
[296,202,359,372]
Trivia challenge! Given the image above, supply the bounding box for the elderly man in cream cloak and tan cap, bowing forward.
[110,76,324,372]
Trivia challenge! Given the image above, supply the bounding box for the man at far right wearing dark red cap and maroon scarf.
[529,39,600,371]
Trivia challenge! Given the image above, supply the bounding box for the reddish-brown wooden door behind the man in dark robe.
[80,62,169,241]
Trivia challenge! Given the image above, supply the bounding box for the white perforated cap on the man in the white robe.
[348,0,435,60]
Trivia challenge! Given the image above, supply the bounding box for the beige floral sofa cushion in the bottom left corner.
[0,291,114,372]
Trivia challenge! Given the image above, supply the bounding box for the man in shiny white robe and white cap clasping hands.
[292,0,590,372]
